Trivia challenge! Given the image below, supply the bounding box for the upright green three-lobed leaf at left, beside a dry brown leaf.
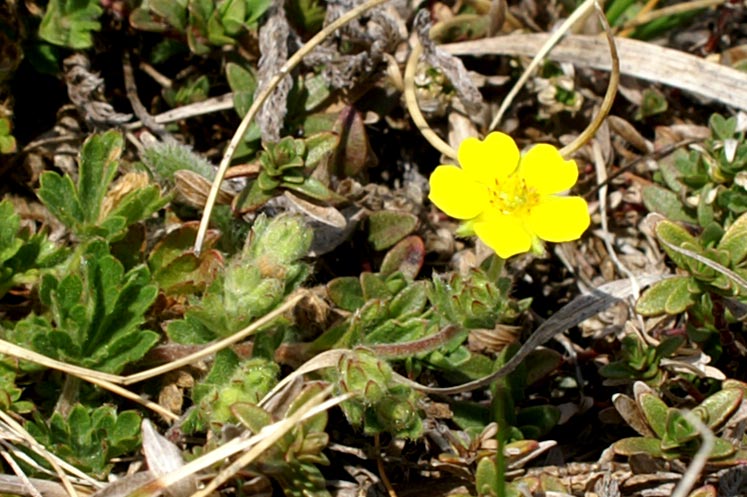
[38,131,167,241]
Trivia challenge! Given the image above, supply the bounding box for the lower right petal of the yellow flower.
[527,196,590,242]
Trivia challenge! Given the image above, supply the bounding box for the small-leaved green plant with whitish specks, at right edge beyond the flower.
[643,114,747,229]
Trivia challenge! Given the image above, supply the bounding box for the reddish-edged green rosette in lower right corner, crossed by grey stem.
[612,380,747,465]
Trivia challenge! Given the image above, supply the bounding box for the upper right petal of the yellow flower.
[519,143,578,195]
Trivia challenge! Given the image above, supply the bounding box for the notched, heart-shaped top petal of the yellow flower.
[458,132,519,186]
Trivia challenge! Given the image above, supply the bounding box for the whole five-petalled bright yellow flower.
[429,133,590,259]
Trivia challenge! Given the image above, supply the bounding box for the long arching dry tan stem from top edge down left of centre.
[195,0,389,255]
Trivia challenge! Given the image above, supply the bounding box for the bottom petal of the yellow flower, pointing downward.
[474,212,532,259]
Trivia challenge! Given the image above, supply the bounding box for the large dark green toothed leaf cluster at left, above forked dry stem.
[8,240,159,373]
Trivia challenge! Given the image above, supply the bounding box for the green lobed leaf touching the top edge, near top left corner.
[39,0,103,50]
